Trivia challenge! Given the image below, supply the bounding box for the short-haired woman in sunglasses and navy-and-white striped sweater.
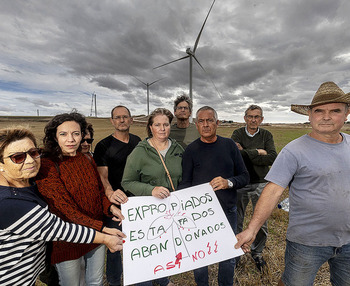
[0,128,123,286]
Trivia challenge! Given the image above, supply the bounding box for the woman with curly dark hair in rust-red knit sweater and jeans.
[36,112,123,286]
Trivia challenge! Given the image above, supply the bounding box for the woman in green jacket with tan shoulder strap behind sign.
[122,108,184,286]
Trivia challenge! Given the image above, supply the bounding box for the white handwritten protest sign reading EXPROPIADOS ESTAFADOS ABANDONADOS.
[122,184,243,285]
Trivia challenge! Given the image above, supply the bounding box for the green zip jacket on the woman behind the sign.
[122,138,184,196]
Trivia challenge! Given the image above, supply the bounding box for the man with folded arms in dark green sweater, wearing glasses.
[231,105,277,271]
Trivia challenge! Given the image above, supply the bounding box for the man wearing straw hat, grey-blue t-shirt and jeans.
[235,82,350,286]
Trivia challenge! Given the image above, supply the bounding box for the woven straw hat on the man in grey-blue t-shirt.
[291,81,350,115]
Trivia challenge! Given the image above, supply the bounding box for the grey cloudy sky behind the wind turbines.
[0,0,350,122]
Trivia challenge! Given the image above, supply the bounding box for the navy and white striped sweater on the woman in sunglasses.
[0,185,95,286]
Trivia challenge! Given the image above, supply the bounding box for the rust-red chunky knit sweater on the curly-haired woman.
[36,152,111,264]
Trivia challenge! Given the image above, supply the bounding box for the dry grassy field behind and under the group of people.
[0,117,336,286]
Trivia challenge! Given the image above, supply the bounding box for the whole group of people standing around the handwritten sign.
[0,82,350,286]
